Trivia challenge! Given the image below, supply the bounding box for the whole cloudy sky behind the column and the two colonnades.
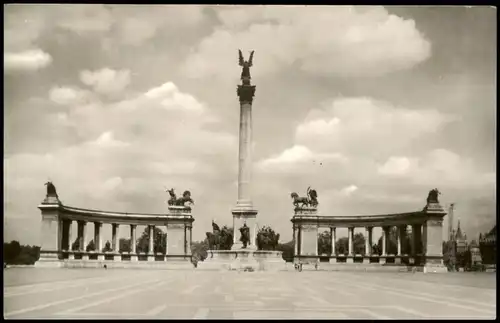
[4,4,496,244]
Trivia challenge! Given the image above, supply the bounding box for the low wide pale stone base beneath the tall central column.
[197,249,286,271]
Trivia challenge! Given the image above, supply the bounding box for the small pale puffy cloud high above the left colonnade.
[80,68,130,94]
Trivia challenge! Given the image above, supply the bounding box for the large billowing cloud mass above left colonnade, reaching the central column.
[4,82,237,243]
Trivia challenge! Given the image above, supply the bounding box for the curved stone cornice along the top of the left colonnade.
[38,201,194,226]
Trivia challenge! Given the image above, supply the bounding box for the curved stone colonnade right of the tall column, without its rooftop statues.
[291,204,446,266]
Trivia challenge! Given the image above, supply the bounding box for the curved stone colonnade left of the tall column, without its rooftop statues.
[37,200,194,266]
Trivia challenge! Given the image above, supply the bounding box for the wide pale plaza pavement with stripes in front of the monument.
[4,268,496,319]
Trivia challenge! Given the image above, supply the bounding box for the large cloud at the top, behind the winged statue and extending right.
[185,6,431,78]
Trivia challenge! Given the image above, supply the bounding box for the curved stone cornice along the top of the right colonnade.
[291,207,447,228]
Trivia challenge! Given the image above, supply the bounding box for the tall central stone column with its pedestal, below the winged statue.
[232,66,258,250]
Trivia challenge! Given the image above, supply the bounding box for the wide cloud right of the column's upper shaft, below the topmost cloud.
[295,97,455,155]
